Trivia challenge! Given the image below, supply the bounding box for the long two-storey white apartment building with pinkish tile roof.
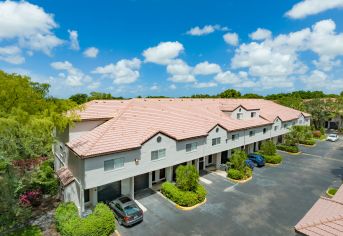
[53,99,310,213]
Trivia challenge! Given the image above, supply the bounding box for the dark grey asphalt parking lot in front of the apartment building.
[118,140,343,235]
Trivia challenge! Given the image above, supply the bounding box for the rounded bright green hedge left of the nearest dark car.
[55,202,115,236]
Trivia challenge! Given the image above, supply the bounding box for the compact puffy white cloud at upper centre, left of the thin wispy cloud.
[143,41,184,65]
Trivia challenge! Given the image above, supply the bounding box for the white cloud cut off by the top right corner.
[286,0,343,19]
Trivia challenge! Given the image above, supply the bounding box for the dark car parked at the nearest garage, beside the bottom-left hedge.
[108,196,143,226]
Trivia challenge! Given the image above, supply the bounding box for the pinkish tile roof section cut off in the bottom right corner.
[295,186,343,236]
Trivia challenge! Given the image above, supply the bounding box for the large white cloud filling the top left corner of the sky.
[0,1,63,55]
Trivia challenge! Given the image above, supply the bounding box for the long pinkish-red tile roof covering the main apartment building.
[67,99,310,158]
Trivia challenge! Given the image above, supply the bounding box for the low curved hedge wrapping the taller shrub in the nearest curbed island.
[161,182,207,207]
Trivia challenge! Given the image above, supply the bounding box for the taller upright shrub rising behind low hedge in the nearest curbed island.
[176,165,199,191]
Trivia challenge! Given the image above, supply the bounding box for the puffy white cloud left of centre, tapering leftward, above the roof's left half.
[92,58,141,84]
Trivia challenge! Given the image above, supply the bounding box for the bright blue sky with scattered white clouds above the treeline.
[0,0,343,97]
